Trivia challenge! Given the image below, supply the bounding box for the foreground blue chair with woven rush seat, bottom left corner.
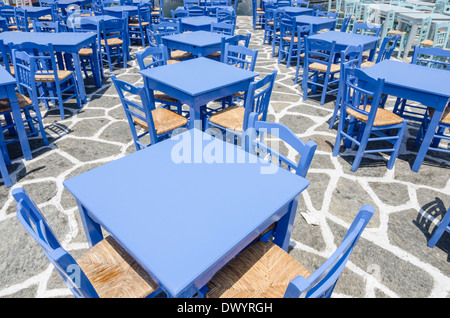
[12,188,161,298]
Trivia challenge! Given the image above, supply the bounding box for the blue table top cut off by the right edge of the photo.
[363,60,450,98]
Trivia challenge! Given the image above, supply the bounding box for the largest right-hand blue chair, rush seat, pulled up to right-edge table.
[333,68,406,171]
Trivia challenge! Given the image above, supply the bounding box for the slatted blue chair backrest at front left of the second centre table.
[111,74,158,147]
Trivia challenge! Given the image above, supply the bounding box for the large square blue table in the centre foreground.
[64,128,309,297]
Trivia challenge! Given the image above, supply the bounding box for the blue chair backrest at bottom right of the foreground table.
[284,205,375,298]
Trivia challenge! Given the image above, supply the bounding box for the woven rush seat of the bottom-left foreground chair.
[77,236,158,298]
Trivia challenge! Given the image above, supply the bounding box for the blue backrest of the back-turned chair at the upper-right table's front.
[303,35,336,74]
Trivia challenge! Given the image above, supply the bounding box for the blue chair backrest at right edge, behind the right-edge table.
[411,45,450,70]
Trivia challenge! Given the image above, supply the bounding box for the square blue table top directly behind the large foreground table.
[139,57,258,97]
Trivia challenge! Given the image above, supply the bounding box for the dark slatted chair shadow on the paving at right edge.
[413,197,450,262]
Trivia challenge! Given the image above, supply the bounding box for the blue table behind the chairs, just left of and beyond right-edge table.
[308,31,381,61]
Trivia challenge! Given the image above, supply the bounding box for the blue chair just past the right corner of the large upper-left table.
[99,18,129,72]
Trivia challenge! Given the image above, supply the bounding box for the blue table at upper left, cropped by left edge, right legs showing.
[0,32,102,103]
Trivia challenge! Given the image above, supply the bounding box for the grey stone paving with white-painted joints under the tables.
[0,17,450,298]
